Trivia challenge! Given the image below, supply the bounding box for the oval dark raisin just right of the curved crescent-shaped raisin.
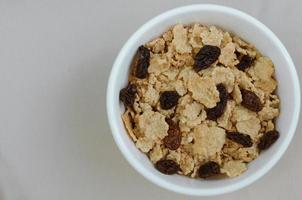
[240,89,263,112]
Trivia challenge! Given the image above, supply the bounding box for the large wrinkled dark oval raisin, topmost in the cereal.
[194,45,221,72]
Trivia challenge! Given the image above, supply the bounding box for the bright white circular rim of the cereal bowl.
[106,4,301,196]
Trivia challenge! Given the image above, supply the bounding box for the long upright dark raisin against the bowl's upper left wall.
[132,46,150,79]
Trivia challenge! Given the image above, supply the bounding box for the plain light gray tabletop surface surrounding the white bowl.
[0,0,302,200]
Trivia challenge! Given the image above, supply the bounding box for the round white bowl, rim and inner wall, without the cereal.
[107,4,300,196]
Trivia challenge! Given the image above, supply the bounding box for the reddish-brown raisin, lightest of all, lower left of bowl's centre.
[163,118,181,150]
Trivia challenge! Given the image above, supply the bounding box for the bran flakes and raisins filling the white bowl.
[120,24,279,178]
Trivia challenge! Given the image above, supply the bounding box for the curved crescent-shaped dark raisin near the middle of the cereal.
[206,83,229,120]
